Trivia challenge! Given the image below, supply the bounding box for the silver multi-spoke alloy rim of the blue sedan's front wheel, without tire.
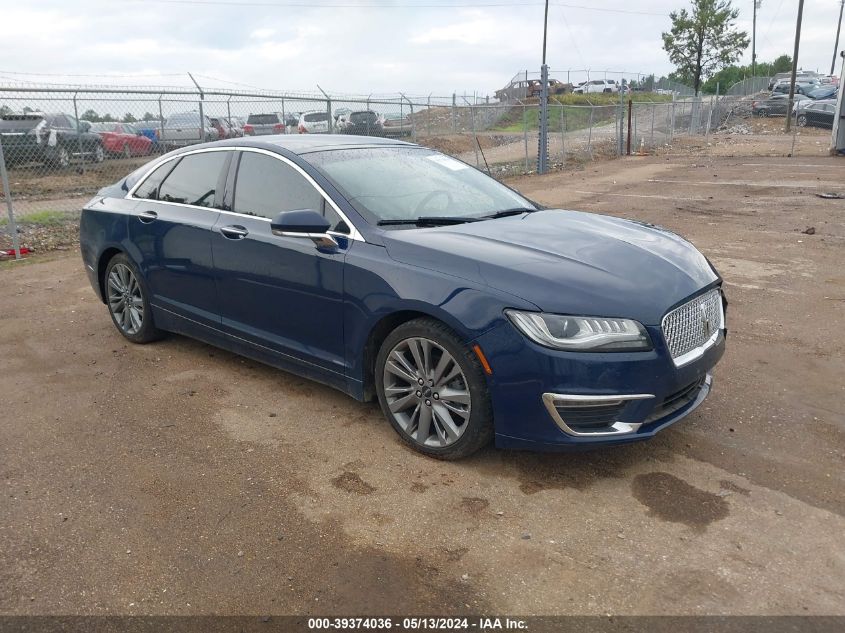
[382,337,472,448]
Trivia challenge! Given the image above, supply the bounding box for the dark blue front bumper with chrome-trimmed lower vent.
[475,323,725,451]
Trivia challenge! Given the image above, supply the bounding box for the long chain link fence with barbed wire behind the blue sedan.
[0,79,820,256]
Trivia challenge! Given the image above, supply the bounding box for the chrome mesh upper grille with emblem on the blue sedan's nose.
[661,288,724,359]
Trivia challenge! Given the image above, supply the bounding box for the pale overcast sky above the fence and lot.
[0,0,845,95]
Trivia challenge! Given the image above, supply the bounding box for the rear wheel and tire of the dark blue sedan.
[103,253,163,343]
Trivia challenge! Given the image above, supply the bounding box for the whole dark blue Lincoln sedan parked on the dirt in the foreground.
[80,135,725,459]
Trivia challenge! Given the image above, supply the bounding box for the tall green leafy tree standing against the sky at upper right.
[663,0,750,94]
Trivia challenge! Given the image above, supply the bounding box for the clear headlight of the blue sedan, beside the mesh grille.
[505,310,651,352]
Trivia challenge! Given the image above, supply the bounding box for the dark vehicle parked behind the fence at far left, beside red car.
[0,112,106,168]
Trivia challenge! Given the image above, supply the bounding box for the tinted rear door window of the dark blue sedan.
[157,152,229,207]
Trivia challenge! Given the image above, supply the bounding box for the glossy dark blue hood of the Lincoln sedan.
[384,210,719,325]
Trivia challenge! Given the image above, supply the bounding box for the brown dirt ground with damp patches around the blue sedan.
[0,145,845,615]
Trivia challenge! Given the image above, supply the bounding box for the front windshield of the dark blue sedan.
[303,146,537,224]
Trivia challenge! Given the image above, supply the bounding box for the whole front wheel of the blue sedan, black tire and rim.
[374,318,493,460]
